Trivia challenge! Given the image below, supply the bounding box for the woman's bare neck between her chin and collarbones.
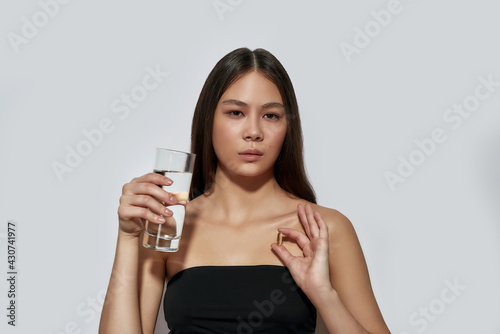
[209,168,288,224]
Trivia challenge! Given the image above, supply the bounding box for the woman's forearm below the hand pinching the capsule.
[311,289,369,334]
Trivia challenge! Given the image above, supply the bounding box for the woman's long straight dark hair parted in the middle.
[189,48,316,203]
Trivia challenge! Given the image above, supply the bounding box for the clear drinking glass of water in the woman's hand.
[142,148,196,252]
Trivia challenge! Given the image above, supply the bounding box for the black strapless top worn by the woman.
[164,265,316,334]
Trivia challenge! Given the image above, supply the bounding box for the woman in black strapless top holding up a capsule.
[100,48,389,333]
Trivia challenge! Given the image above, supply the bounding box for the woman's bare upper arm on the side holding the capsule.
[325,210,389,333]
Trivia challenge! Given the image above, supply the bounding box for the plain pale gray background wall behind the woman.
[0,0,500,334]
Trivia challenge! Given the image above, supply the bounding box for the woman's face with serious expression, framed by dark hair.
[212,71,287,176]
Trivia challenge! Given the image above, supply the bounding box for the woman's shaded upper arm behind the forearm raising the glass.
[138,246,166,334]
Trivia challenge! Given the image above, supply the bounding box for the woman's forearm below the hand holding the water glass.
[99,233,142,334]
